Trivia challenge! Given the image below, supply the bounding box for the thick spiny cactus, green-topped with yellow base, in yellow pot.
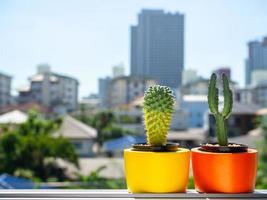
[143,85,175,146]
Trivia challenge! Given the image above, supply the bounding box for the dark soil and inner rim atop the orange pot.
[199,143,248,153]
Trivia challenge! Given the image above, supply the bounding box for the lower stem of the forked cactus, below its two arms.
[215,114,228,146]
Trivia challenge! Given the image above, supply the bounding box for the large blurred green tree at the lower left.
[0,111,78,180]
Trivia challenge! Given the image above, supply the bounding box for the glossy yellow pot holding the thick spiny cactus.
[124,148,190,193]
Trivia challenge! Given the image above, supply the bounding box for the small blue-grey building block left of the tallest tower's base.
[98,76,112,109]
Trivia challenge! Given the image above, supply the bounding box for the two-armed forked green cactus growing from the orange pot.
[208,73,233,146]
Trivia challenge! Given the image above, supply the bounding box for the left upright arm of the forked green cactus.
[208,73,219,114]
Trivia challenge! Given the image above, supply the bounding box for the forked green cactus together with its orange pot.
[191,74,257,193]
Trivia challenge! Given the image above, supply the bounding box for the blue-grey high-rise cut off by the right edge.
[245,37,267,85]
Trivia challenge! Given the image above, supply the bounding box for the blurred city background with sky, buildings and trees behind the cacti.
[0,0,267,189]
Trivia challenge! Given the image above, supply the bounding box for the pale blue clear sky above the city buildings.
[0,0,267,98]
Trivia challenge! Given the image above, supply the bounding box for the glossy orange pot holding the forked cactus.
[191,148,258,193]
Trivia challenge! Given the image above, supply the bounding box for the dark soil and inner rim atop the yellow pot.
[132,143,179,152]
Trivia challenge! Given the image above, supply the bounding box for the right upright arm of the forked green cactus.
[222,74,233,119]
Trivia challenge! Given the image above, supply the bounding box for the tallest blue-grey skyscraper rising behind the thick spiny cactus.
[131,10,184,88]
